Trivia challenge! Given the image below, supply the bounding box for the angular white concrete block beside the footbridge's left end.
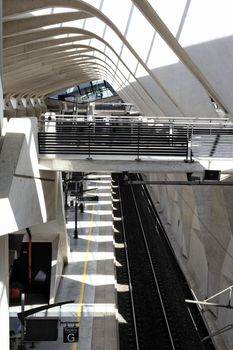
[0,118,56,235]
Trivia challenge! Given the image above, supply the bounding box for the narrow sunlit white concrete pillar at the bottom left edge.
[0,235,9,350]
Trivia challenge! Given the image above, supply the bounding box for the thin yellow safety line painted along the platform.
[72,205,95,350]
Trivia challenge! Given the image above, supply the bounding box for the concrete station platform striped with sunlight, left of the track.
[9,174,118,350]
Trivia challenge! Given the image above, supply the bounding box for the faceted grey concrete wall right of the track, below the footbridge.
[144,174,233,350]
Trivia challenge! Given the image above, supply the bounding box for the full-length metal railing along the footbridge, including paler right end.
[38,115,233,162]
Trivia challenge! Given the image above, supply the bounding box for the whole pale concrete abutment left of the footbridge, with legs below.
[0,118,69,338]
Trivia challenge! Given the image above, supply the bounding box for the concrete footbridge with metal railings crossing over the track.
[38,114,233,172]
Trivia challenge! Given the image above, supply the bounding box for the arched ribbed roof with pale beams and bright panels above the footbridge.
[3,0,233,117]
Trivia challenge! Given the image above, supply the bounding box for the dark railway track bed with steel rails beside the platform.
[113,175,214,350]
